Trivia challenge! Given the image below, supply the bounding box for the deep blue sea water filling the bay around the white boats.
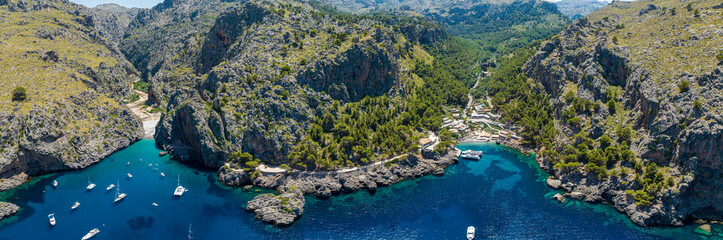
[0,140,723,240]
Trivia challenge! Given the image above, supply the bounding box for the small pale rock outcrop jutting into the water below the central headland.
[246,190,305,227]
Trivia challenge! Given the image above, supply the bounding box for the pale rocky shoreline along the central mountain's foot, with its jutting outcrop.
[218,148,461,227]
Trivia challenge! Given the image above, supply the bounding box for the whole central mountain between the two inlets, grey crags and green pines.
[120,0,475,169]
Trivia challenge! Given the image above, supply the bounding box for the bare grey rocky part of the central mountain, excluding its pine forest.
[120,1,439,167]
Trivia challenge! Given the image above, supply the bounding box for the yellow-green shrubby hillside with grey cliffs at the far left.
[0,0,142,190]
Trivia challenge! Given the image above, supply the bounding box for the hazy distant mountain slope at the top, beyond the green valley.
[326,0,570,61]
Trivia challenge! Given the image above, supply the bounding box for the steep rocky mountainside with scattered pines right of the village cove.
[524,0,723,226]
